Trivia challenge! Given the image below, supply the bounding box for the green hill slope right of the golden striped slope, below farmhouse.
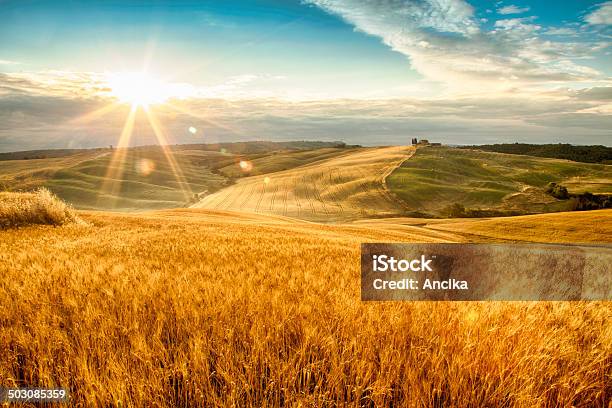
[388,147,612,215]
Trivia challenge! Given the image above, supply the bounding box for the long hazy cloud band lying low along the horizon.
[0,73,612,151]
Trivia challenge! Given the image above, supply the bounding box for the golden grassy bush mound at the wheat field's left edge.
[0,188,83,229]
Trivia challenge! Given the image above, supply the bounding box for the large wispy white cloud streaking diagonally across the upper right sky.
[307,0,601,92]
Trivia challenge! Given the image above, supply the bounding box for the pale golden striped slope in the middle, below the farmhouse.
[194,146,414,221]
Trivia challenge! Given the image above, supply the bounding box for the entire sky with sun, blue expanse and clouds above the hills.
[0,0,612,151]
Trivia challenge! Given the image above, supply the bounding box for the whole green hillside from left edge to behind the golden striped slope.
[0,142,352,211]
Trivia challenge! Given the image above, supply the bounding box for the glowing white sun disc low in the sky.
[107,72,171,106]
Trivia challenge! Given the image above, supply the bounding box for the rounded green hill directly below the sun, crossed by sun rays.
[44,148,231,211]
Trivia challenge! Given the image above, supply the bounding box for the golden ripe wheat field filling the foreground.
[0,203,612,407]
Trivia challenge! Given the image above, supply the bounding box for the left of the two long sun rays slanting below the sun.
[98,105,138,207]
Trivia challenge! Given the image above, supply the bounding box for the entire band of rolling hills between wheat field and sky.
[0,142,612,217]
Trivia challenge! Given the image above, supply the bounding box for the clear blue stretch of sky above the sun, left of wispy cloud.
[0,1,417,94]
